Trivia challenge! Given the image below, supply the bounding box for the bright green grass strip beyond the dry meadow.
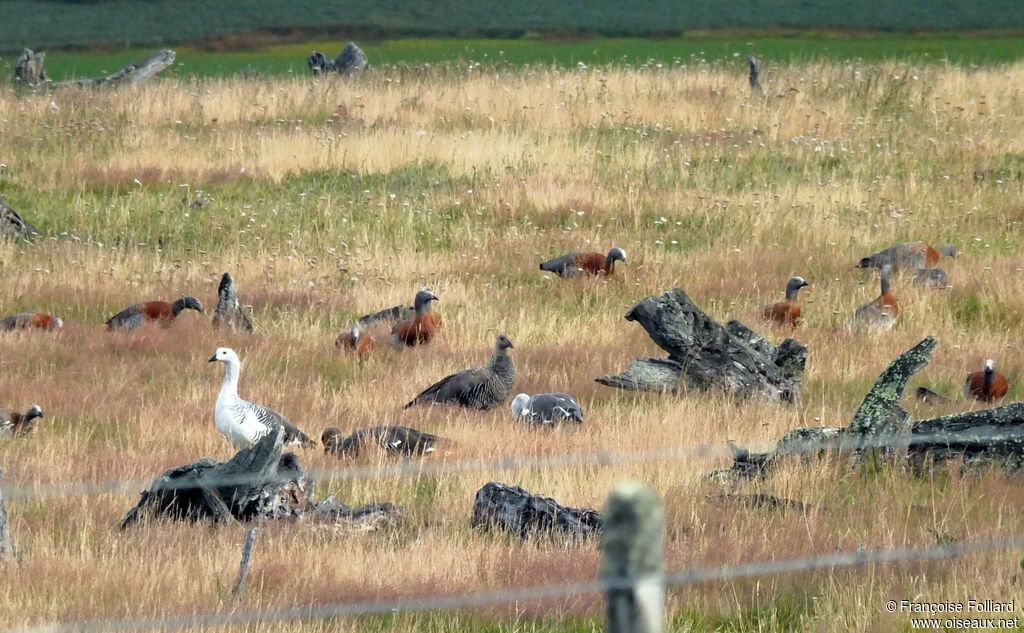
[6,34,1024,80]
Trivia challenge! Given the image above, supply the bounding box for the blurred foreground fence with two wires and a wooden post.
[0,431,1024,633]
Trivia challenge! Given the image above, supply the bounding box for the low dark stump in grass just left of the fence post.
[472,481,601,537]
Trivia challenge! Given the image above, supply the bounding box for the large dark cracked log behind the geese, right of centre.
[596,288,807,402]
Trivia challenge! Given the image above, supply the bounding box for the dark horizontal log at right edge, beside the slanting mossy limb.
[907,403,1024,471]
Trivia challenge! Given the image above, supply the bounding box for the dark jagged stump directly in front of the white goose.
[121,428,313,530]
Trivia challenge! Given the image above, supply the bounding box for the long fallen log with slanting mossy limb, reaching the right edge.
[709,336,1024,482]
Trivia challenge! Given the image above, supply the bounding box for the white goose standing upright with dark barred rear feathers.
[210,347,315,449]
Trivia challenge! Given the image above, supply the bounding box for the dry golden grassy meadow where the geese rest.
[0,59,1024,632]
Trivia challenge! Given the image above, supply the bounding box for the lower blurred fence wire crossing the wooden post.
[8,536,1024,633]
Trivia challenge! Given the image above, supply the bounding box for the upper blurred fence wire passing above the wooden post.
[0,426,1021,500]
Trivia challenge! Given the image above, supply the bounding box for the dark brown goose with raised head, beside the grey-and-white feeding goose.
[404,334,515,410]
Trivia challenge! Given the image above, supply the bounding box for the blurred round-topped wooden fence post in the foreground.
[601,481,665,633]
